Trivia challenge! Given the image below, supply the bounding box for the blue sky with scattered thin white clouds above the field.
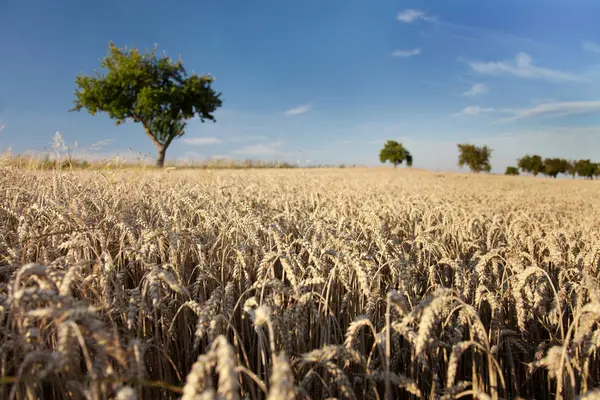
[0,0,600,172]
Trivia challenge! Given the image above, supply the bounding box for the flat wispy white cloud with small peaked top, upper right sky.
[469,53,581,82]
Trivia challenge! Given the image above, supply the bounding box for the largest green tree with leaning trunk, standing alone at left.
[71,42,222,167]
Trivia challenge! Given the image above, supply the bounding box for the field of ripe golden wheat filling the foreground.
[0,167,600,400]
